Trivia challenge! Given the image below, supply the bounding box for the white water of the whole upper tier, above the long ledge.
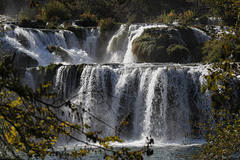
[0,24,210,66]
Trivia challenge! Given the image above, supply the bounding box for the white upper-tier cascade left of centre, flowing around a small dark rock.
[0,25,95,66]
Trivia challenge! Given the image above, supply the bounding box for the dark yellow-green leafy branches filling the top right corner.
[204,0,240,26]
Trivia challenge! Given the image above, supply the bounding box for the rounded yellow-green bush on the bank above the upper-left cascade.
[44,1,70,21]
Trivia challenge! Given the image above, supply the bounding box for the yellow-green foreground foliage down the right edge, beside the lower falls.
[192,28,240,159]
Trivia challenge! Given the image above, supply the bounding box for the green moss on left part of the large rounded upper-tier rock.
[132,28,182,62]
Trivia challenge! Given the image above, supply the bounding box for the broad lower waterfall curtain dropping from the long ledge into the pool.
[23,64,210,143]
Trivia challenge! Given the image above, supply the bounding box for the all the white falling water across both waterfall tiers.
[1,24,210,149]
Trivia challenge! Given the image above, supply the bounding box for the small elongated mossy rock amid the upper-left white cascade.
[47,45,74,63]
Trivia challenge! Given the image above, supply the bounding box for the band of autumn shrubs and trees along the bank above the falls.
[12,0,191,26]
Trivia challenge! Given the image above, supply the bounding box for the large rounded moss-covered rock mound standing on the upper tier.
[132,26,202,63]
